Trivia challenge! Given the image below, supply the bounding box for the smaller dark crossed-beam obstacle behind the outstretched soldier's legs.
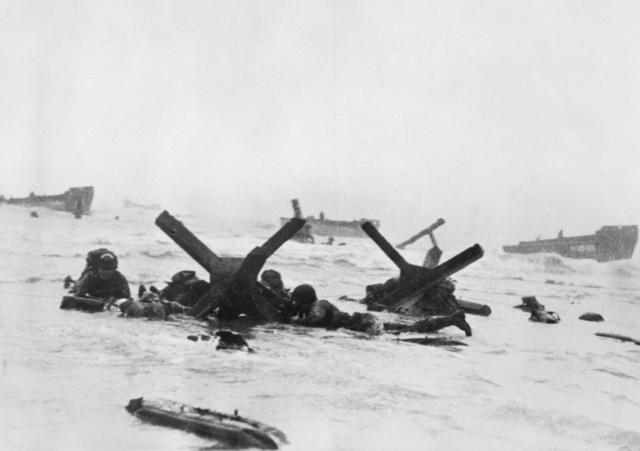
[362,222,484,313]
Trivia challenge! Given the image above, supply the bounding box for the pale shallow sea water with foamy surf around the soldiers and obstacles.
[0,205,640,451]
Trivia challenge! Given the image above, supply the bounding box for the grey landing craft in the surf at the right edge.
[503,226,638,262]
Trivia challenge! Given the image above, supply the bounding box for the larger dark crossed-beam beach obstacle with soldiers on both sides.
[155,211,305,320]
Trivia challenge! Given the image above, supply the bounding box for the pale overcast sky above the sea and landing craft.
[0,0,640,249]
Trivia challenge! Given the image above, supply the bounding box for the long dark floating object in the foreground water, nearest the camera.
[126,398,288,449]
